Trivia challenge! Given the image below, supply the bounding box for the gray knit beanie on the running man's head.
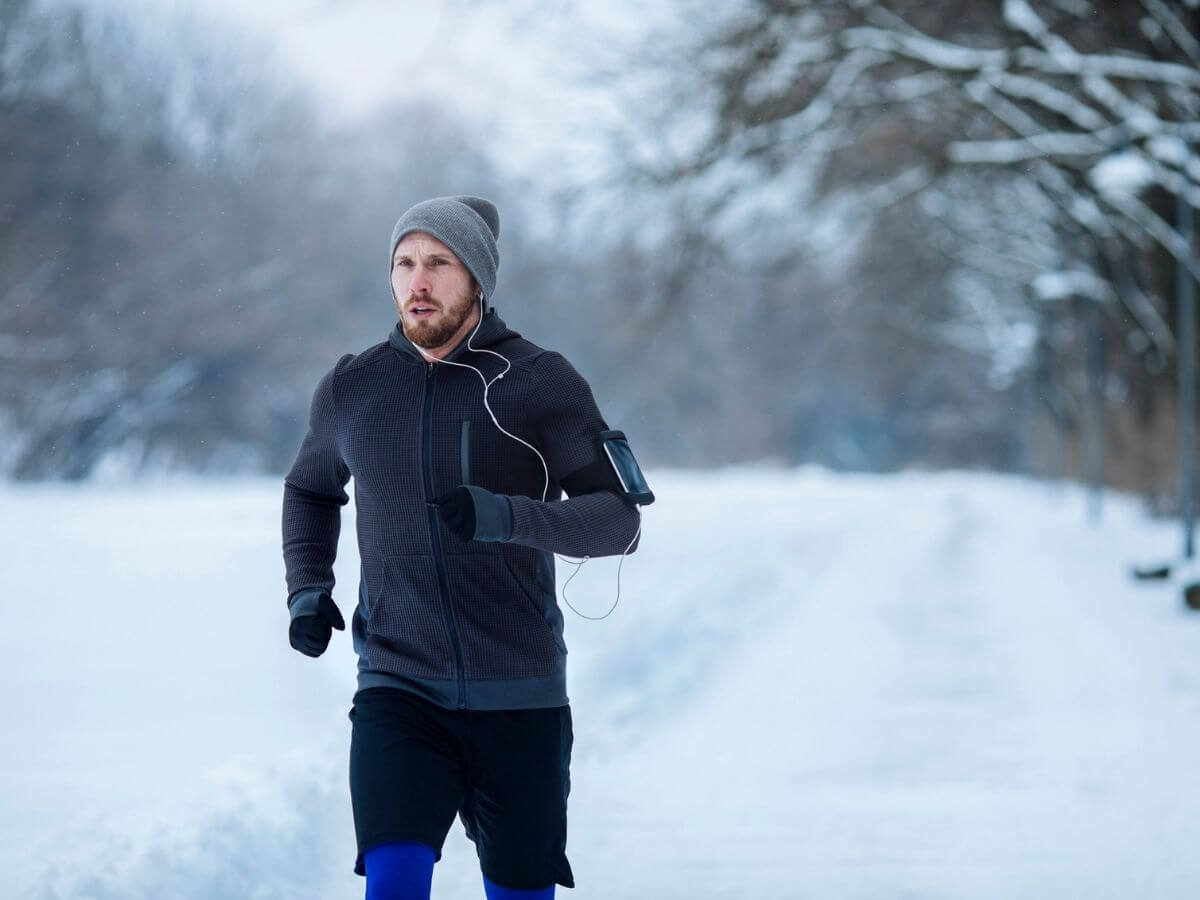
[388,196,500,300]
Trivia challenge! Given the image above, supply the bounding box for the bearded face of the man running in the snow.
[391,232,479,352]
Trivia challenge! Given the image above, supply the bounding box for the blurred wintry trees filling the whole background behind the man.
[0,0,1200,513]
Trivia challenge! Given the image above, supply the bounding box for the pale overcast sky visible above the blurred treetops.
[65,0,697,247]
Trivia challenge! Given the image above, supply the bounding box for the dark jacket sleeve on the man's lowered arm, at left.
[283,355,350,618]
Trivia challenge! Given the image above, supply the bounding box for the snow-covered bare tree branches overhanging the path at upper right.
[604,0,1200,494]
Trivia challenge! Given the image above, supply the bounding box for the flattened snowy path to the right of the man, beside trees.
[568,476,1200,898]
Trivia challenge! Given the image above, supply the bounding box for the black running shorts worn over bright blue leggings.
[349,688,575,890]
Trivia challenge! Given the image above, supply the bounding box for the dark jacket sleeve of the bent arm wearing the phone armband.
[509,352,641,557]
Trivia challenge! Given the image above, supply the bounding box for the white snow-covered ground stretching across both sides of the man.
[0,469,1200,900]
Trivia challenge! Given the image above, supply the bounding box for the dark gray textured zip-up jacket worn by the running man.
[283,308,640,709]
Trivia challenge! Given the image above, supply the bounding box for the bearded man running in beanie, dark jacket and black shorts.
[283,197,648,900]
